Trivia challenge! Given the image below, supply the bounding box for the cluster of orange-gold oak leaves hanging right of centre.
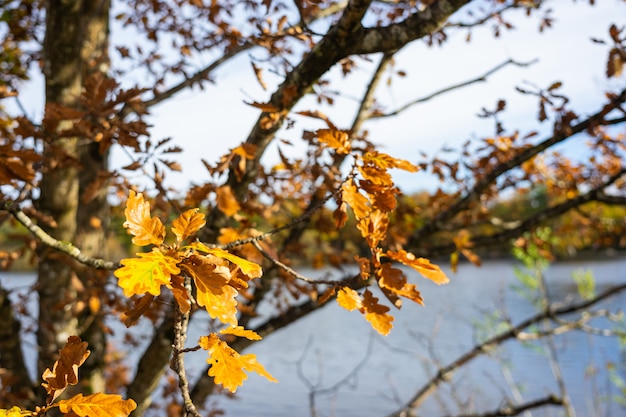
[334,150,448,335]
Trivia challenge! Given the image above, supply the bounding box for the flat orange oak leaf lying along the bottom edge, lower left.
[57,392,137,417]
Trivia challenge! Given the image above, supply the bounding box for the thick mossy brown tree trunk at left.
[37,0,110,400]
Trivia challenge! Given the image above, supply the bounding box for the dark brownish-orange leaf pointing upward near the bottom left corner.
[41,336,91,400]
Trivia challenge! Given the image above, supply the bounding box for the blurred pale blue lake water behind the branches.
[0,258,626,417]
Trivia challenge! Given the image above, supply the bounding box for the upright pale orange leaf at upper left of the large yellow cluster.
[123,190,165,246]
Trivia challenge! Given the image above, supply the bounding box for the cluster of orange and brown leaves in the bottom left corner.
[0,336,137,417]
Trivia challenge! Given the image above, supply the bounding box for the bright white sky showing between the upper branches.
[12,0,626,192]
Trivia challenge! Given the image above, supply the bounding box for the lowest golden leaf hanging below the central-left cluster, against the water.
[198,333,278,392]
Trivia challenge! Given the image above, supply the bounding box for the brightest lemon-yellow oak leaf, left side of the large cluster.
[114,248,180,297]
